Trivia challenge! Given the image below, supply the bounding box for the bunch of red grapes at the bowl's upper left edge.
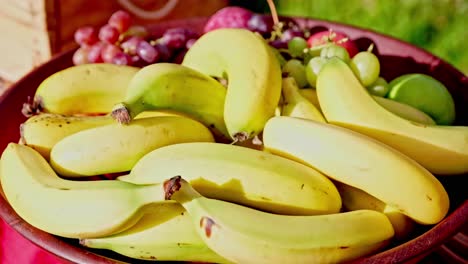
[73,10,199,67]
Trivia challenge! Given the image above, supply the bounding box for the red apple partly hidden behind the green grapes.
[307,30,359,58]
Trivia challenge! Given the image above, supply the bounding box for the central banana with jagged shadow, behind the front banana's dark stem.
[117,142,341,215]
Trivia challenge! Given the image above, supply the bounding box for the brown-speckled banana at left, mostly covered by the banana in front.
[20,113,114,160]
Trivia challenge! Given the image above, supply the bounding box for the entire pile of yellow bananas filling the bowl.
[0,24,460,263]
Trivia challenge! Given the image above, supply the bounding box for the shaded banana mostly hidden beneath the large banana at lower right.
[334,181,415,240]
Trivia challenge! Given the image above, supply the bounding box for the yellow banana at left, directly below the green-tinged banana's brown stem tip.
[50,116,214,176]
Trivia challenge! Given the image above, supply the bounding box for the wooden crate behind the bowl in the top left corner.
[0,0,228,81]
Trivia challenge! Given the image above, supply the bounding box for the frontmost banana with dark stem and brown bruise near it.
[164,176,394,264]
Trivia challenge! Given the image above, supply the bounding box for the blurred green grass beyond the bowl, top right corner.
[233,0,468,74]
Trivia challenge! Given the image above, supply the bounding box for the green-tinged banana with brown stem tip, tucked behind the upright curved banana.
[112,63,229,138]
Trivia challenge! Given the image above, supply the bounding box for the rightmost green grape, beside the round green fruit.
[349,51,380,86]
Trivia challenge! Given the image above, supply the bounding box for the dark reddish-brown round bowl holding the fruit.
[0,18,468,263]
